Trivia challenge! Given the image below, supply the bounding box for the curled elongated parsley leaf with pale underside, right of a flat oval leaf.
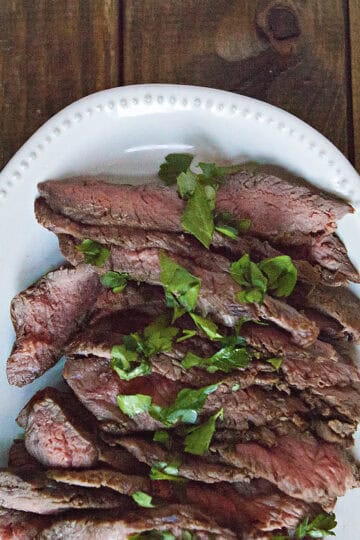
[150,384,218,427]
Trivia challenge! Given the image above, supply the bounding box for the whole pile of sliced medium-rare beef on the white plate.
[0,173,360,539]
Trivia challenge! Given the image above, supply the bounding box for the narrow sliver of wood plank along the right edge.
[349,0,360,172]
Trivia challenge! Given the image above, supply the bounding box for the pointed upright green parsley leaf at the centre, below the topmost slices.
[160,252,201,320]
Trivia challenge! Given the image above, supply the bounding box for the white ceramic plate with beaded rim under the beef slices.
[0,85,360,540]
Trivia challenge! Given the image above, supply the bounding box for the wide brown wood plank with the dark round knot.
[124,0,348,157]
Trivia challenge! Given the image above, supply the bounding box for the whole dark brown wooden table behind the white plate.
[0,0,360,169]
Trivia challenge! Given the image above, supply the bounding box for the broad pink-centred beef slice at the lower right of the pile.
[217,435,357,508]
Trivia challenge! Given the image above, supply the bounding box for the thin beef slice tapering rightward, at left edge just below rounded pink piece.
[0,469,129,514]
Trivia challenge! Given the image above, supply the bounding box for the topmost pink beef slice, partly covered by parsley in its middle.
[38,172,353,243]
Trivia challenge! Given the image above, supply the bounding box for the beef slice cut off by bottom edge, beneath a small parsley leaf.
[39,504,236,540]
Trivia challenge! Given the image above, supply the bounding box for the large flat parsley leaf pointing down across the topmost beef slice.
[181,184,215,248]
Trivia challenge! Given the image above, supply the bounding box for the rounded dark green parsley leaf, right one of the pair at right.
[258,255,297,297]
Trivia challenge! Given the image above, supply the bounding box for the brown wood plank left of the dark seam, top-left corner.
[0,0,119,169]
